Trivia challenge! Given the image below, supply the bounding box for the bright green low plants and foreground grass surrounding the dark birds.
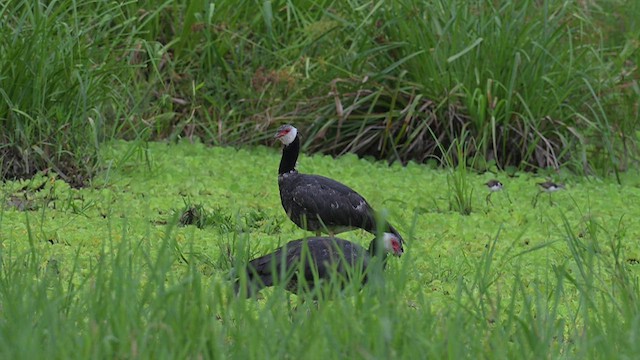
[0,143,640,358]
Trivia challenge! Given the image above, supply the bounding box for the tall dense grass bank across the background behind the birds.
[0,0,640,186]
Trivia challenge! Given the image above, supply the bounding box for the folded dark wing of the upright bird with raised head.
[288,174,376,232]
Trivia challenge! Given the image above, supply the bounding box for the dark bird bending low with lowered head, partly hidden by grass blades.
[235,233,403,297]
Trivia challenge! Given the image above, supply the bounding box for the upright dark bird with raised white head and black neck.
[275,125,403,245]
